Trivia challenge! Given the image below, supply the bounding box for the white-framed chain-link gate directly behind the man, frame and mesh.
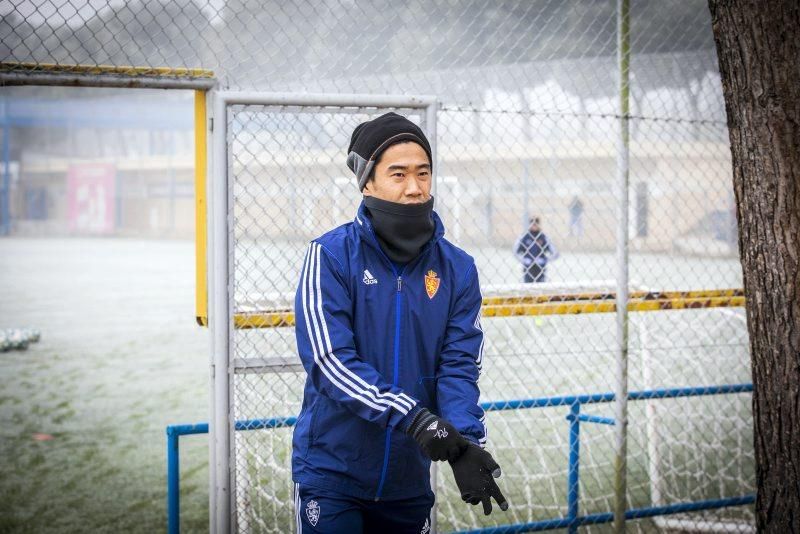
[209,92,436,532]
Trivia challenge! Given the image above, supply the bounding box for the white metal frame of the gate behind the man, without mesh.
[207,91,438,534]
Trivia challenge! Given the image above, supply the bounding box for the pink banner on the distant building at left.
[67,163,116,234]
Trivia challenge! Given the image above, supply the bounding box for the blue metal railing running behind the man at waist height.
[167,384,756,534]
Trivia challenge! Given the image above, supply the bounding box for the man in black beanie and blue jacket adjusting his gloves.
[292,113,508,534]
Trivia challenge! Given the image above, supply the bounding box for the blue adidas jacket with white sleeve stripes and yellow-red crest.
[292,203,486,500]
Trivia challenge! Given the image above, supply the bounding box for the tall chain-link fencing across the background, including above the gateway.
[0,0,755,532]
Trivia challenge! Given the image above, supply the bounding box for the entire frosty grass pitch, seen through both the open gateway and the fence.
[0,238,752,532]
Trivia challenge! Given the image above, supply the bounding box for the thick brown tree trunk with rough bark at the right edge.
[709,0,800,533]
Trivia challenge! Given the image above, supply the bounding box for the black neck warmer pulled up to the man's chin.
[364,196,434,263]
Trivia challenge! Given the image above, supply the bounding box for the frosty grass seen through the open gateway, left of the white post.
[0,238,208,533]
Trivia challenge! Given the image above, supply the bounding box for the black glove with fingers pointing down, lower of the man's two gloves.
[450,443,508,515]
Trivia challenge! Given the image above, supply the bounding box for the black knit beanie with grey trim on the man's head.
[347,112,433,191]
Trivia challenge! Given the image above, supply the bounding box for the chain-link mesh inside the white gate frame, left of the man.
[229,105,432,532]
